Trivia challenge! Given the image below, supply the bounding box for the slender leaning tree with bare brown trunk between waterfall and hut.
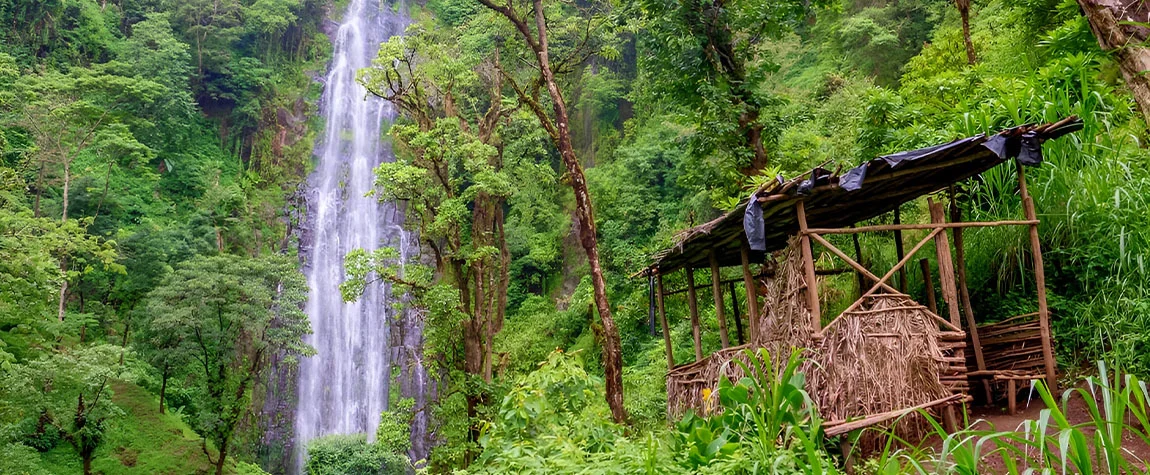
[480,0,627,423]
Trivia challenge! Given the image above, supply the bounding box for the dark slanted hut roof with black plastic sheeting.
[643,116,1082,274]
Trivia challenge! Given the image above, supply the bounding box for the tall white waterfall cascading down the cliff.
[294,0,426,472]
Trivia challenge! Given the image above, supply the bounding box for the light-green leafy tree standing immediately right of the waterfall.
[345,24,516,460]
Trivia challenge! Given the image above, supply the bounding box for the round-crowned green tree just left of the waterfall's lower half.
[144,255,314,475]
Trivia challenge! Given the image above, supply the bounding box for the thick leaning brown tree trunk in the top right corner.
[1078,0,1150,124]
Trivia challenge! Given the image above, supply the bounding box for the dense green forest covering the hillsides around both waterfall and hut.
[0,0,1150,474]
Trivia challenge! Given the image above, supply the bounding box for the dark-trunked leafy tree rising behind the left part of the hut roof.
[638,0,827,181]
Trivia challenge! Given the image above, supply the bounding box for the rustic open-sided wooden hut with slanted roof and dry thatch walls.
[642,117,1082,435]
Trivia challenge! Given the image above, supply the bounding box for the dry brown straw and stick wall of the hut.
[667,239,967,437]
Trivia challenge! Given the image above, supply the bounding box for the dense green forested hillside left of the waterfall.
[0,0,330,474]
